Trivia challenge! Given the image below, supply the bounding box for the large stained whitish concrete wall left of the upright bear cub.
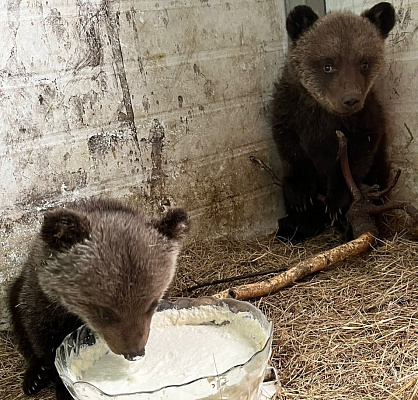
[0,0,287,326]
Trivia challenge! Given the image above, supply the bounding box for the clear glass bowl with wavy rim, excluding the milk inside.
[55,297,273,400]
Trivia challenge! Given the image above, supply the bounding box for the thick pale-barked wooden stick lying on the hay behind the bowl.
[213,232,376,300]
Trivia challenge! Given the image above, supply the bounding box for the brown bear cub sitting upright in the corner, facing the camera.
[272,2,395,241]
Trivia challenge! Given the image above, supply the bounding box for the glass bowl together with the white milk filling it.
[55,297,273,400]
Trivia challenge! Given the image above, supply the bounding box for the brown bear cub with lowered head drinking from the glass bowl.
[9,200,189,399]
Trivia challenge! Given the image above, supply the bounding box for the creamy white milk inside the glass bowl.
[69,306,268,398]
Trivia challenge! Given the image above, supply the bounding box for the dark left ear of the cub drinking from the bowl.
[41,208,90,251]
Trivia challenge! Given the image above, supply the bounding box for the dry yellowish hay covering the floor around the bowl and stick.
[0,231,418,400]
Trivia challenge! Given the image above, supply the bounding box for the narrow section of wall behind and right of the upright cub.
[326,0,418,206]
